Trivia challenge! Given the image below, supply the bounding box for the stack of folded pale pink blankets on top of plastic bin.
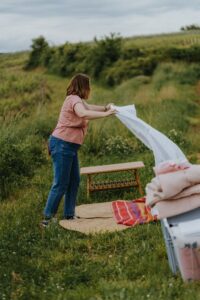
[146,164,200,219]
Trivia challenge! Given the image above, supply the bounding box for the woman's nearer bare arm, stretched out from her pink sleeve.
[74,103,116,120]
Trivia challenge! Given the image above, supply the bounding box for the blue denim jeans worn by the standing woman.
[44,136,80,218]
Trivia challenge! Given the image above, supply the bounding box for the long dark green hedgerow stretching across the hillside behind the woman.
[24,33,200,86]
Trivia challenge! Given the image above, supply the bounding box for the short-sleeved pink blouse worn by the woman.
[52,95,88,144]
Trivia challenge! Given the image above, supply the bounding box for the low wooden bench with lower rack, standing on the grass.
[80,161,144,197]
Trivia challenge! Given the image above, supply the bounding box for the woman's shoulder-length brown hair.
[67,74,90,99]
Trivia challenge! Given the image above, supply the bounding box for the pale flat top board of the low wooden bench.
[80,161,144,175]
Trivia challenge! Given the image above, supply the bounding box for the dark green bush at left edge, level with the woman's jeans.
[0,126,45,200]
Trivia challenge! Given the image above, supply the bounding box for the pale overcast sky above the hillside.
[0,0,200,52]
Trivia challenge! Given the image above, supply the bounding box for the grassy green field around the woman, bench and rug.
[0,34,200,300]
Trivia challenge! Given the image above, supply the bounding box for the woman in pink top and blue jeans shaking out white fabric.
[42,74,116,226]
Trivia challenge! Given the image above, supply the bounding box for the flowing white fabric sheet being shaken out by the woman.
[112,105,188,166]
